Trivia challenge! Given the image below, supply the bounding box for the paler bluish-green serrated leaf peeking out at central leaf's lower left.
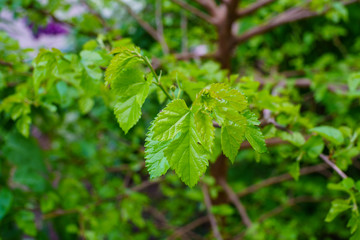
[145,129,171,179]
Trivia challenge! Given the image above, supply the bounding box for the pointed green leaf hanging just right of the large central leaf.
[221,116,246,163]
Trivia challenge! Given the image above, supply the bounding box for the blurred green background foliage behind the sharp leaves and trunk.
[0,0,360,240]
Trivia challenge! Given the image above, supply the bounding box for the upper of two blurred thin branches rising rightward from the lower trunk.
[237,163,329,197]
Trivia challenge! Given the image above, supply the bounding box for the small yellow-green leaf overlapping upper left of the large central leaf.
[153,99,190,141]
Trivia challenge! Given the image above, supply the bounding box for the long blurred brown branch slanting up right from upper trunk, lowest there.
[235,0,359,44]
